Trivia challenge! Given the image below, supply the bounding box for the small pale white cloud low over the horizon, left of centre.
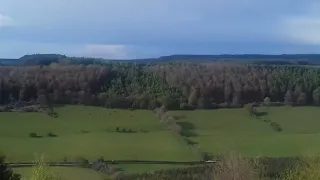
[81,44,128,59]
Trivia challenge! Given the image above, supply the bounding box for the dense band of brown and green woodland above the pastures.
[0,63,320,109]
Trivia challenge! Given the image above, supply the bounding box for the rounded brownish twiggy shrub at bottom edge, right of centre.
[213,153,259,180]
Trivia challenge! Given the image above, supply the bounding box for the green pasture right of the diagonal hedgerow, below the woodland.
[173,107,320,157]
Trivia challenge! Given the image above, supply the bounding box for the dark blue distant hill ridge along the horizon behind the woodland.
[0,54,320,66]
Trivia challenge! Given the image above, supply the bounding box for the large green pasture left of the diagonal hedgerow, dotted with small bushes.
[0,106,196,162]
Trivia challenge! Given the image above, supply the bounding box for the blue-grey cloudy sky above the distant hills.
[0,0,320,59]
